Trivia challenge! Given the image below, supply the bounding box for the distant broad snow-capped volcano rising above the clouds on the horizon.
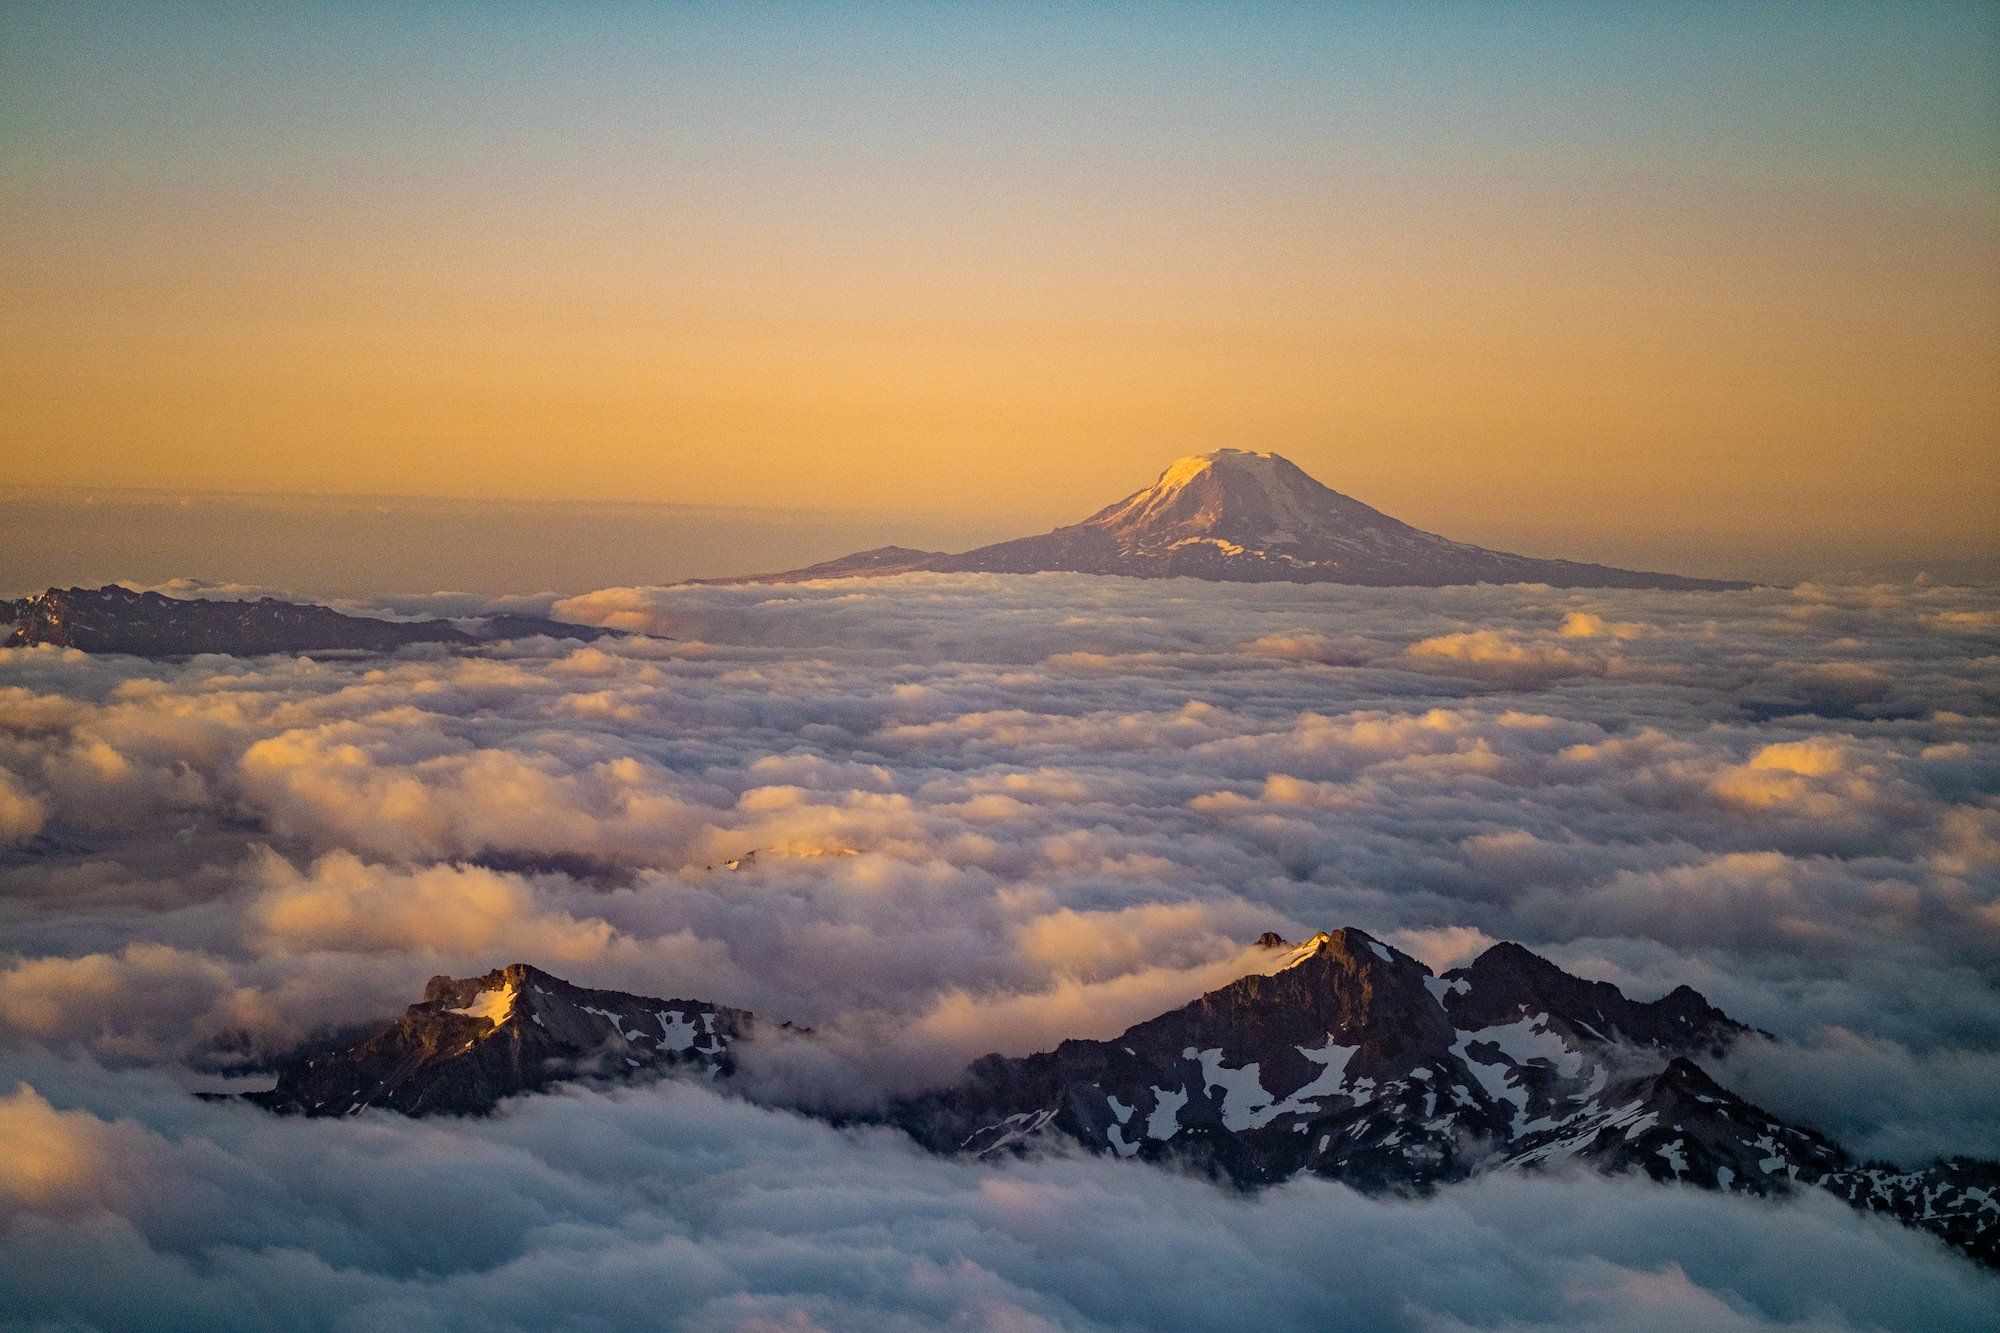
[710,448,1748,590]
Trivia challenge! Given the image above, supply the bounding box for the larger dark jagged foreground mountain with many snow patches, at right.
[894,929,2000,1263]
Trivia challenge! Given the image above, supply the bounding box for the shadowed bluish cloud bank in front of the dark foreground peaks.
[0,1061,2000,1329]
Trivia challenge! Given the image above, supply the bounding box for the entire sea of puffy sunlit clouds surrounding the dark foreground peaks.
[0,574,2000,1329]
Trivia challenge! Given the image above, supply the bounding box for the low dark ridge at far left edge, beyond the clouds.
[0,584,612,658]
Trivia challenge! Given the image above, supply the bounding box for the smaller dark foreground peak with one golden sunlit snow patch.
[248,963,752,1115]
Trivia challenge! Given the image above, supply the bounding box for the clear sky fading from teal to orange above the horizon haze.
[0,2,2000,556]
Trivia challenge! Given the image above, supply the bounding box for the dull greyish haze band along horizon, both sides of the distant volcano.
[0,474,2000,596]
